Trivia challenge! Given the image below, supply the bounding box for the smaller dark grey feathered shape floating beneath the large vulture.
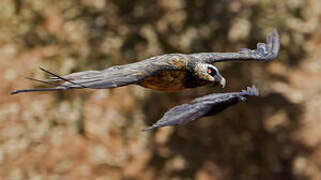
[143,86,259,131]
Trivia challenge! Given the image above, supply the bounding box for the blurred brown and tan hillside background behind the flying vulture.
[0,0,321,180]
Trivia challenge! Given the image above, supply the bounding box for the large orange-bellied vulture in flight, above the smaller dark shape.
[11,30,280,94]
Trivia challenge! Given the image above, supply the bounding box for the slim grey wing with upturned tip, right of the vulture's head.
[191,29,280,64]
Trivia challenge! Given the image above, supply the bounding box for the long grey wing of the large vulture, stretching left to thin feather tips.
[11,54,186,94]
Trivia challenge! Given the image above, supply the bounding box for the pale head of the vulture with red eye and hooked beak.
[195,63,226,88]
